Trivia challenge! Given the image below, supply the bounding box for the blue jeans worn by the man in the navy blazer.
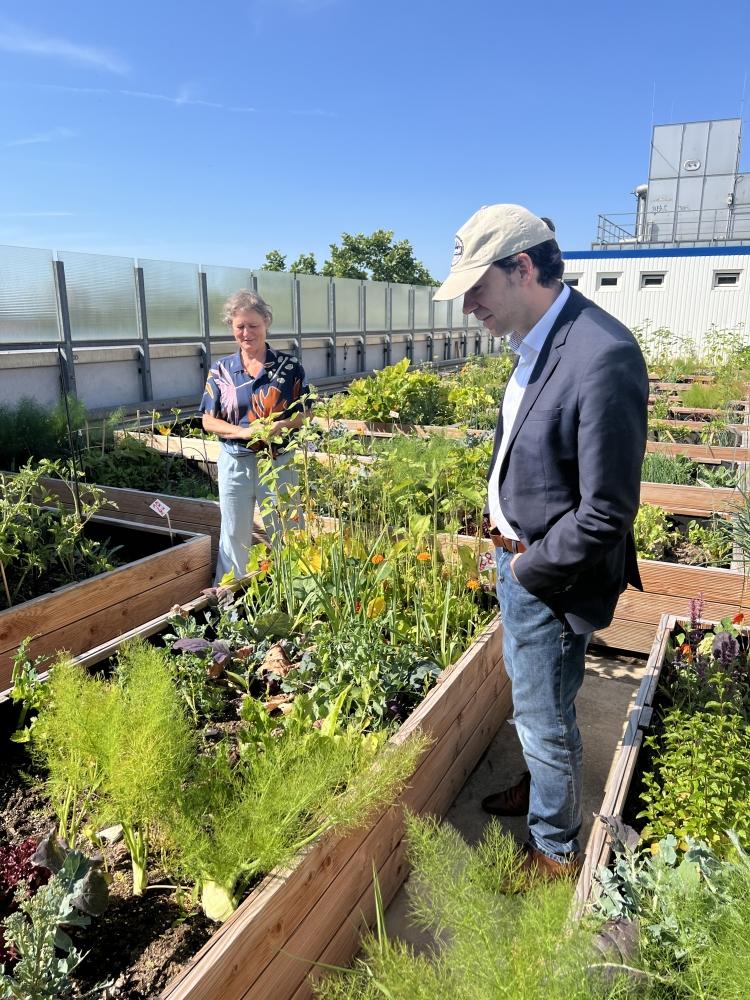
[495,548,591,862]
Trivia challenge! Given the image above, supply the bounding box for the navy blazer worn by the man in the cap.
[490,288,648,633]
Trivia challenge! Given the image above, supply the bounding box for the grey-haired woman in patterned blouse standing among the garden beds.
[200,288,309,584]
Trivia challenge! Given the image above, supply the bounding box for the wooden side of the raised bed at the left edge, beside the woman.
[0,516,211,691]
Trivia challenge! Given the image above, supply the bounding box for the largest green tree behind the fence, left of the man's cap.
[321,229,440,285]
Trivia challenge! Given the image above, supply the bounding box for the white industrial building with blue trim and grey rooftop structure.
[563,118,750,347]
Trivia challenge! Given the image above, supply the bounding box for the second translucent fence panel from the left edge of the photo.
[57,250,139,341]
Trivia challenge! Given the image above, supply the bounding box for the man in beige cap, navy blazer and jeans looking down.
[435,205,648,878]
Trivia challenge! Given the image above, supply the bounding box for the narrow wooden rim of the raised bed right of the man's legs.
[575,611,676,913]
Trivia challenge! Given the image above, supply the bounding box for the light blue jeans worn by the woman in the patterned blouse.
[215,442,304,586]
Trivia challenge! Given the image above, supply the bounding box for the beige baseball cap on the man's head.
[433,205,555,300]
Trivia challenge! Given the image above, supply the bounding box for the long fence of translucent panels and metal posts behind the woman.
[0,246,492,407]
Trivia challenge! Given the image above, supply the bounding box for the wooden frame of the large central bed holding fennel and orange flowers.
[73,601,511,1000]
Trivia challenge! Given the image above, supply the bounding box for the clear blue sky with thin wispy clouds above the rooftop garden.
[0,0,750,277]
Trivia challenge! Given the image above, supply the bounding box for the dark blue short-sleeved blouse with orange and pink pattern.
[200,345,310,457]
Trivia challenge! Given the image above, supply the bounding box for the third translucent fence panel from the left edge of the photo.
[138,260,201,340]
